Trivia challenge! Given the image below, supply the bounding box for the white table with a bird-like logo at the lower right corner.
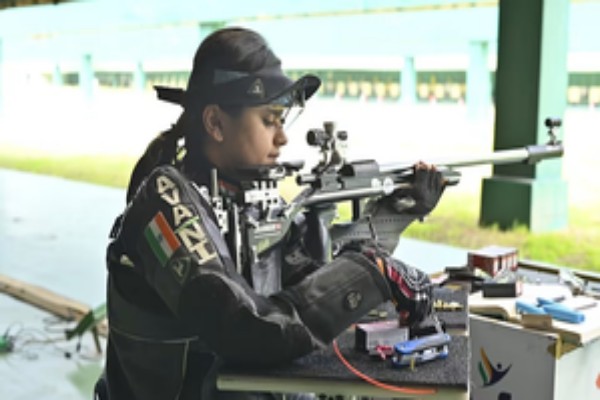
[469,282,600,400]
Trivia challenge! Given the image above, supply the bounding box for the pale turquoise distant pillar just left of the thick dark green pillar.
[466,41,492,118]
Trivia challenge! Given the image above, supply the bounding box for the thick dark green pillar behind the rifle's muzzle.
[480,0,569,232]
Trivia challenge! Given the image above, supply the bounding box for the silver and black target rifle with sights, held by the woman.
[210,118,564,275]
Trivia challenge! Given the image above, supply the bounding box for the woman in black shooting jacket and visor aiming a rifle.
[99,28,442,400]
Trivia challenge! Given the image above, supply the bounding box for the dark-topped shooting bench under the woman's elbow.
[217,290,470,399]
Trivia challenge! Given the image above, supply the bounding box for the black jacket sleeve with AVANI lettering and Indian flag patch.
[116,166,390,364]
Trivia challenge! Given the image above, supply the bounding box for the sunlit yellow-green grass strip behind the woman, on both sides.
[0,149,600,272]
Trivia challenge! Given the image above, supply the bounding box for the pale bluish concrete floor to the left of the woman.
[0,170,124,400]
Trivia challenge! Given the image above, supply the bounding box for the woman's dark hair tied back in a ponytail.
[127,27,281,202]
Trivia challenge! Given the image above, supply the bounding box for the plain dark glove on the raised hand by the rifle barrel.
[391,162,446,215]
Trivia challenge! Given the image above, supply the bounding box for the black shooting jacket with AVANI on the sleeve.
[105,159,404,400]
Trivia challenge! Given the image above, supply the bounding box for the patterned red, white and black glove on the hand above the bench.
[341,240,433,326]
